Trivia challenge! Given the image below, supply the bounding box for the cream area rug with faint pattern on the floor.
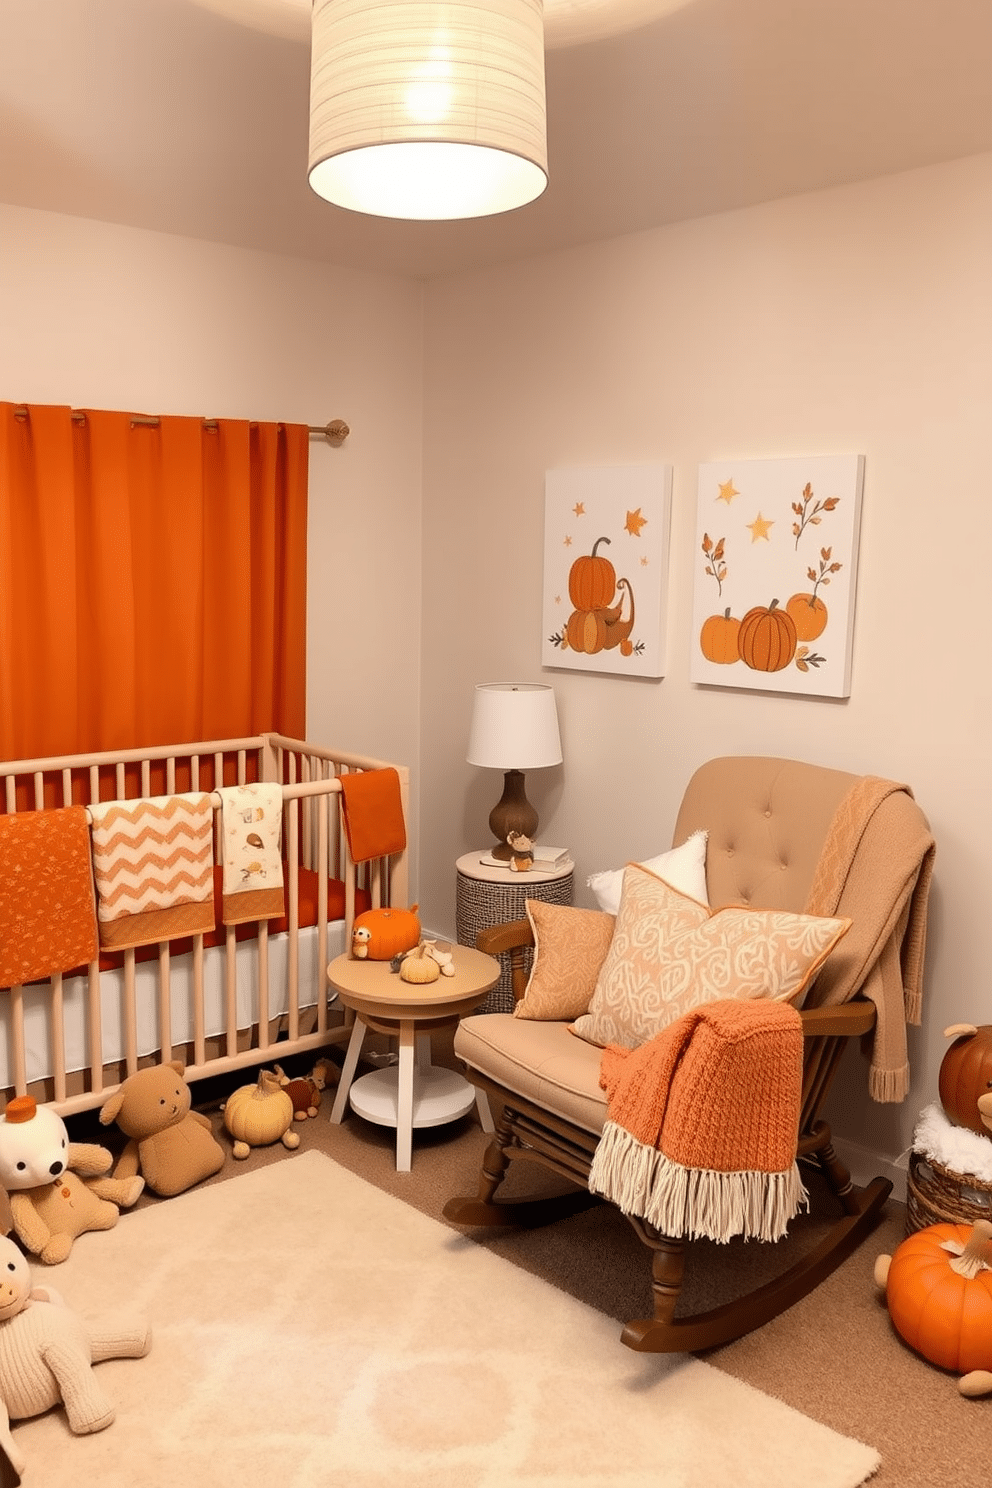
[13,1152,879,1488]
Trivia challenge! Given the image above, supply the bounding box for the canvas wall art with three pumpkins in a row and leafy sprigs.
[690,455,864,698]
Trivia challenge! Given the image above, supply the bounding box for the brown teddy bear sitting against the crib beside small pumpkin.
[100,1059,225,1198]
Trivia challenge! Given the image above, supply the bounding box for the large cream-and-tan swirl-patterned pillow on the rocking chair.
[573,863,851,1049]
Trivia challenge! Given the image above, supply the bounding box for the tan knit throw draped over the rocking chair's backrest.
[806,775,935,1101]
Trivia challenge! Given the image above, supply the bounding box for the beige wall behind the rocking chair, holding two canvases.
[421,148,992,1162]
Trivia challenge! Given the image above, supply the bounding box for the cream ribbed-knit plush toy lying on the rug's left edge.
[0,1237,152,1476]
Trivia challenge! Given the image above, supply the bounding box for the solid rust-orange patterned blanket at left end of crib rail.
[0,806,97,987]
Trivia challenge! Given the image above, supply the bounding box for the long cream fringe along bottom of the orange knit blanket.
[589,1122,809,1244]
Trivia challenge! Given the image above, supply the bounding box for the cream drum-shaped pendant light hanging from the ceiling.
[309,0,547,220]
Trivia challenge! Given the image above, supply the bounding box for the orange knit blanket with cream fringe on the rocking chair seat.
[589,1000,808,1242]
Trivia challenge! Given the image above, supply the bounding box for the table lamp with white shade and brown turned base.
[467,682,562,862]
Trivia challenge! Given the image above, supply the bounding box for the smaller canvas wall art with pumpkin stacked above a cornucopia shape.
[541,464,672,677]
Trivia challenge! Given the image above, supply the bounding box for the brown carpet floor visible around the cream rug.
[60,1039,992,1488]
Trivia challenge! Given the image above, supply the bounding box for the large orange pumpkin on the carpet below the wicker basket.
[875,1219,992,1396]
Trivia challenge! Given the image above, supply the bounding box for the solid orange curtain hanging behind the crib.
[0,403,308,759]
